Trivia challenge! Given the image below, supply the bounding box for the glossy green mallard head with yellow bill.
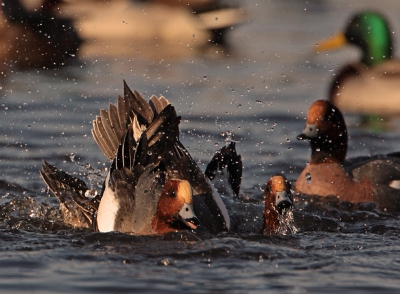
[316,11,393,66]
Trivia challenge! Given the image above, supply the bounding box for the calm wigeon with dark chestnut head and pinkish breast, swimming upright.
[295,100,400,212]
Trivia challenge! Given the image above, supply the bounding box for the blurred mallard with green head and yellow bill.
[316,11,400,118]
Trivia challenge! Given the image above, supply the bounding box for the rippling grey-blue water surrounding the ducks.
[0,0,400,293]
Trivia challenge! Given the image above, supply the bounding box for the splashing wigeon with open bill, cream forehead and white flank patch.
[41,101,199,235]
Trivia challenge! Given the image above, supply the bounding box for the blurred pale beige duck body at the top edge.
[60,0,246,58]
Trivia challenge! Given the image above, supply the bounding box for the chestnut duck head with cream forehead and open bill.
[152,179,200,234]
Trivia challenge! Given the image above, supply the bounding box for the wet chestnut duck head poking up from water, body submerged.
[263,175,293,235]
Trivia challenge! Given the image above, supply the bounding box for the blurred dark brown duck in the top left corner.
[0,0,82,72]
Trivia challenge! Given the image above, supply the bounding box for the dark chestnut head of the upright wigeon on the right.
[297,100,347,164]
